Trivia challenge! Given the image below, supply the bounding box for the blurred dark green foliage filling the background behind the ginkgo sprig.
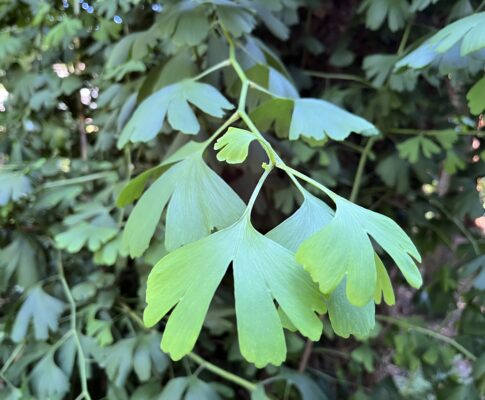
[0,0,485,399]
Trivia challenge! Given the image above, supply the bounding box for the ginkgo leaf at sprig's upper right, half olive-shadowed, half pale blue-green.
[252,98,379,141]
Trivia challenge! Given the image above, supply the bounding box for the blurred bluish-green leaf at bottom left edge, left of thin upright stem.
[30,352,70,399]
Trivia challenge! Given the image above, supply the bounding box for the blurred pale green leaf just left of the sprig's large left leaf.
[54,215,118,253]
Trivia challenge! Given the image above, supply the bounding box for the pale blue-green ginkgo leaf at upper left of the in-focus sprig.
[117,80,234,148]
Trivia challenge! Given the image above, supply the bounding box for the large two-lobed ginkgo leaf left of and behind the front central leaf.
[123,147,244,257]
